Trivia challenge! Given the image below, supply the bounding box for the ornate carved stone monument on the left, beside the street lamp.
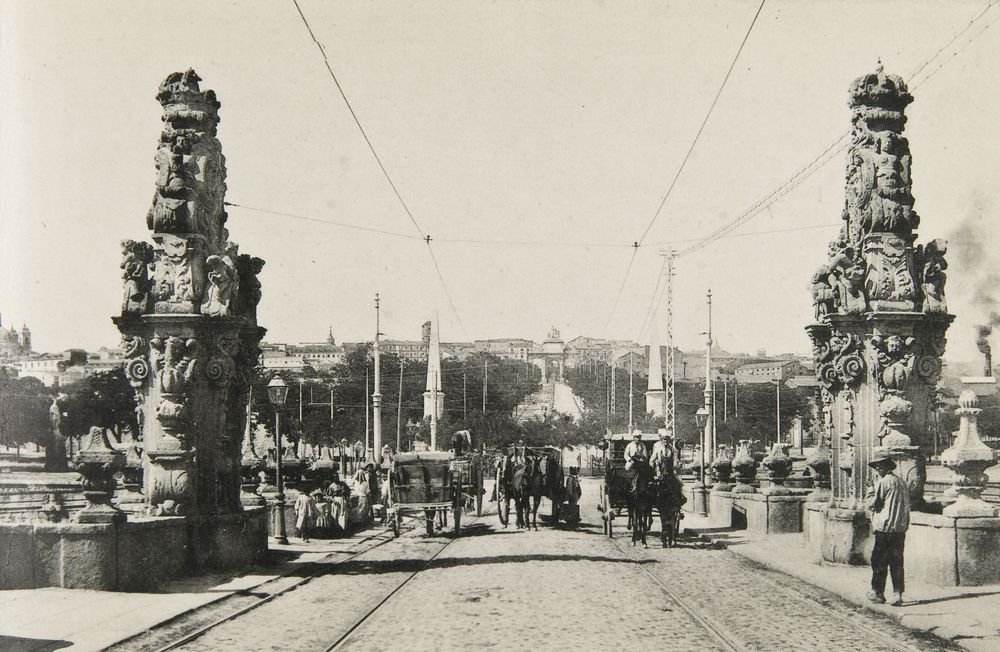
[114,70,265,515]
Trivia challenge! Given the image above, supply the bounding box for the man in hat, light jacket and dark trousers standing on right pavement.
[868,454,910,607]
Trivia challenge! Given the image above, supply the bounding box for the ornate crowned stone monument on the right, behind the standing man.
[806,64,954,561]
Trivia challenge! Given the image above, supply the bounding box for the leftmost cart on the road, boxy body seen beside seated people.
[386,451,466,537]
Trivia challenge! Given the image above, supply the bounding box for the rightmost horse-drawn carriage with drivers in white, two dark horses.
[598,433,686,545]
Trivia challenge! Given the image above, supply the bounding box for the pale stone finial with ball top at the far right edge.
[941,389,997,517]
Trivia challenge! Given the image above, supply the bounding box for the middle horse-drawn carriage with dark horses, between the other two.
[496,446,580,530]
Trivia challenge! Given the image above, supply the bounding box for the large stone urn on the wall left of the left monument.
[73,426,125,523]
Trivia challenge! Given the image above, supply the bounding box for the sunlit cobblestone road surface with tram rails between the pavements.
[154,482,950,651]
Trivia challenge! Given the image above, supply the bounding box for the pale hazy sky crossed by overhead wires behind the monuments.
[0,0,1000,359]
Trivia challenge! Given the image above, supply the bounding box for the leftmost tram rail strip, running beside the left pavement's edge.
[107,518,423,652]
